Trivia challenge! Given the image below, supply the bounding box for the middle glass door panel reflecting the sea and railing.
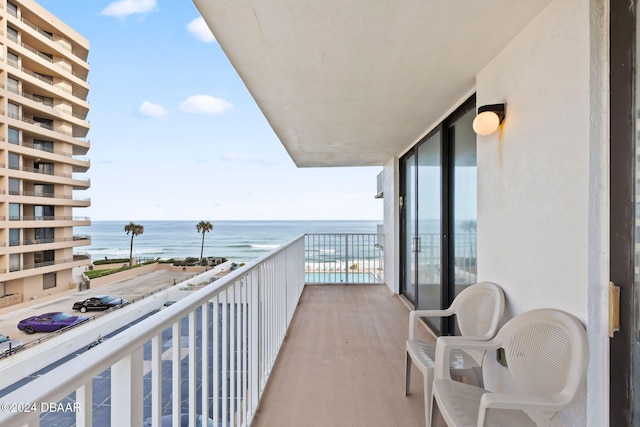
[414,131,443,332]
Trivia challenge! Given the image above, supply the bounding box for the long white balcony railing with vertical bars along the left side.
[0,236,305,426]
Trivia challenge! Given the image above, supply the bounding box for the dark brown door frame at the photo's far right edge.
[609,1,637,426]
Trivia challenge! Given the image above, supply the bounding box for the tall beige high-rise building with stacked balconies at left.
[0,0,90,305]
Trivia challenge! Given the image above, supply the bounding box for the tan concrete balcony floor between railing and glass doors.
[252,285,431,427]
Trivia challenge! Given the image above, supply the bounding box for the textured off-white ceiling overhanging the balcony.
[194,0,549,167]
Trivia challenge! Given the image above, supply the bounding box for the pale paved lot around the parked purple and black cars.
[0,269,194,343]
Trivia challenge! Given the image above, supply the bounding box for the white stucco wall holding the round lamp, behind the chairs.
[476,0,608,426]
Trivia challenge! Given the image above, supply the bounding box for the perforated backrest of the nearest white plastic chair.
[496,309,589,410]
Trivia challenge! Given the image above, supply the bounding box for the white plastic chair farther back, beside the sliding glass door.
[405,282,505,425]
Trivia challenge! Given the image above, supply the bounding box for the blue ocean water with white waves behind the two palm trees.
[80,221,382,262]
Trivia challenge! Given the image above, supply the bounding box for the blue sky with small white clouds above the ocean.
[39,0,382,221]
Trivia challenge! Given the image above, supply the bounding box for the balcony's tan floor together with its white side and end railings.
[0,234,438,426]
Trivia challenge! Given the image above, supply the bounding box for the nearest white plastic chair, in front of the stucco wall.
[431,309,589,427]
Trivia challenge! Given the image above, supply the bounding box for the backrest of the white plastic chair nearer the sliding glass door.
[450,282,505,339]
